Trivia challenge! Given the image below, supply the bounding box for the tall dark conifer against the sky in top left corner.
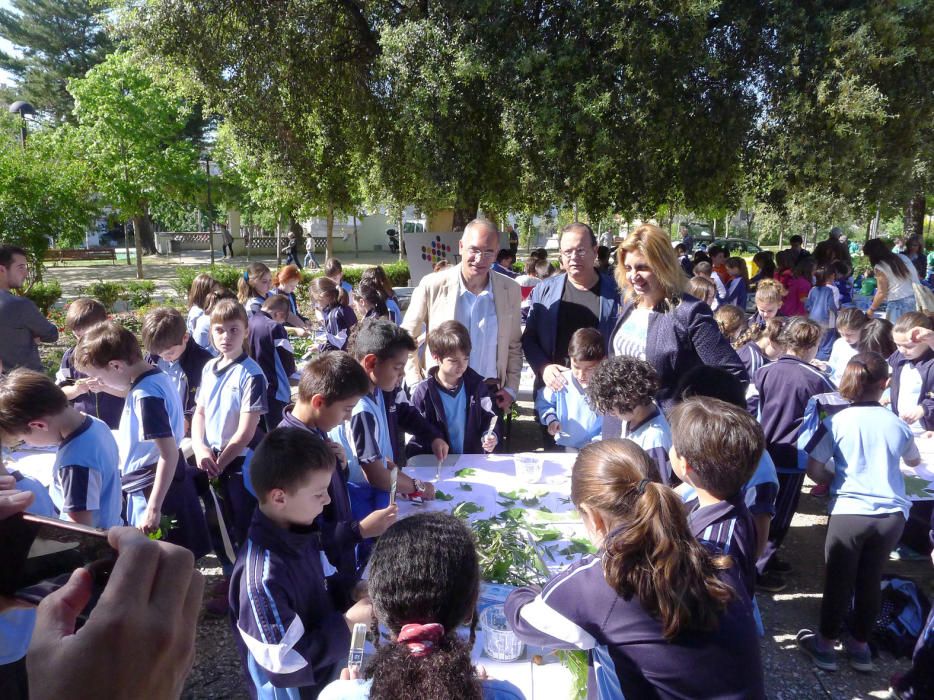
[0,0,113,121]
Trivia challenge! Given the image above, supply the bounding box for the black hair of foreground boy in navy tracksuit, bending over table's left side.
[250,428,335,503]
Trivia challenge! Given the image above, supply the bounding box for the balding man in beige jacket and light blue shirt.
[402,219,522,410]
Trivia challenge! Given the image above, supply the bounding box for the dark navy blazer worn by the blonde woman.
[612,292,749,414]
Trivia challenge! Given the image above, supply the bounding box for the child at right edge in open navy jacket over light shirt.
[889,311,934,436]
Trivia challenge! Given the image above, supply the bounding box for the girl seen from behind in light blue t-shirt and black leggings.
[797,353,921,673]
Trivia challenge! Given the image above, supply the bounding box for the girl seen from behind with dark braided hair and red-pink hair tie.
[318,513,523,700]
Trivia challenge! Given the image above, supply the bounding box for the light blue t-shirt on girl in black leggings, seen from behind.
[808,403,920,519]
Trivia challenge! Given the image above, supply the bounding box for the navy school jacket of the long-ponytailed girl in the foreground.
[506,556,765,700]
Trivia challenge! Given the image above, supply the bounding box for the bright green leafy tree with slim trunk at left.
[68,52,202,278]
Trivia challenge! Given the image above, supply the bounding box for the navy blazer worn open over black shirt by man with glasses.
[522,272,619,377]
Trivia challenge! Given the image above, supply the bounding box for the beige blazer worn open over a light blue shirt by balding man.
[402,265,522,394]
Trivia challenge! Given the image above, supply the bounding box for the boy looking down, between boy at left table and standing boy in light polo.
[142,308,214,435]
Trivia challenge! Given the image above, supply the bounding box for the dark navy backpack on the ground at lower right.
[870,575,931,659]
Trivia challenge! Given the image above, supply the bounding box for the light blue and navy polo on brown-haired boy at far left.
[50,416,123,530]
